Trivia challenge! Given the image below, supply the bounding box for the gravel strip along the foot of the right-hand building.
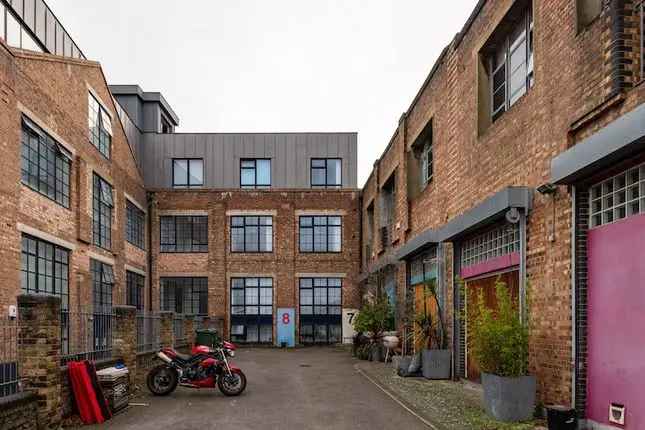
[355,361,543,430]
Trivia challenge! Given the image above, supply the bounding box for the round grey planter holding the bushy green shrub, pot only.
[482,373,535,422]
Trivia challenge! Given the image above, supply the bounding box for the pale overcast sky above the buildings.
[47,0,476,186]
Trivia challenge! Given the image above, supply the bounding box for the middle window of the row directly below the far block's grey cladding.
[231,216,273,252]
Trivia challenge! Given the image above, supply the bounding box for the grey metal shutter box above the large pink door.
[551,104,645,184]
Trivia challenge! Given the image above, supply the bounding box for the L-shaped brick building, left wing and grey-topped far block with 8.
[0,0,360,358]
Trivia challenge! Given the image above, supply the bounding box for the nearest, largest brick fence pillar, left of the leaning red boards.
[18,295,62,428]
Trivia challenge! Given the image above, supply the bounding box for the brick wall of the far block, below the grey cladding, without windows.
[152,190,360,337]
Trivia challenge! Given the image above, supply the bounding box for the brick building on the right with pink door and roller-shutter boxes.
[360,0,645,428]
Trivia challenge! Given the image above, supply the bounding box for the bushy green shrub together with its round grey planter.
[469,280,536,422]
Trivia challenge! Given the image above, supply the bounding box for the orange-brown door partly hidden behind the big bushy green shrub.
[466,270,520,383]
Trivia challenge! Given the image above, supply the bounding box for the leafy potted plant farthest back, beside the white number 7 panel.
[353,297,394,361]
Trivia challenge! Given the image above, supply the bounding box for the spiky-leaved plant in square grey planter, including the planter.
[412,279,452,379]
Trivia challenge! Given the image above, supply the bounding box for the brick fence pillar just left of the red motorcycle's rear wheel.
[112,305,137,374]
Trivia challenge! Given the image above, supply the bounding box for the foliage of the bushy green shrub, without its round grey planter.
[469,281,529,377]
